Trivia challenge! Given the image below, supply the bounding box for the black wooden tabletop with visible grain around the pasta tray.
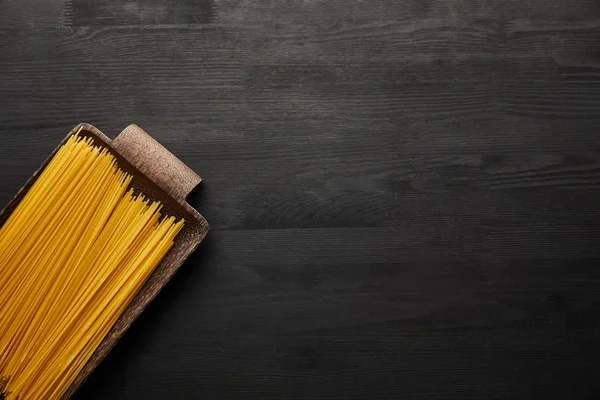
[0,0,600,399]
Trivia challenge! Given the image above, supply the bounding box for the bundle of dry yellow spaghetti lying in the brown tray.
[0,135,183,400]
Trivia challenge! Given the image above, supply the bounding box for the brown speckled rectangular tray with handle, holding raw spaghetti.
[0,123,209,398]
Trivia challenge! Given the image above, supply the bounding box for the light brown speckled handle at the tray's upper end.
[112,125,202,203]
